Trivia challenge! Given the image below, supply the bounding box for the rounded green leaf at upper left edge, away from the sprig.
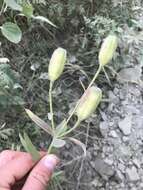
[1,22,22,44]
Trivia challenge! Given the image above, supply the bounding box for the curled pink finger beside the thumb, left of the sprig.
[0,153,44,189]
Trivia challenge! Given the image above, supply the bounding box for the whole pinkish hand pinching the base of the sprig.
[0,150,59,190]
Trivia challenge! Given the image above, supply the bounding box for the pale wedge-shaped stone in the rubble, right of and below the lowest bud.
[118,116,132,135]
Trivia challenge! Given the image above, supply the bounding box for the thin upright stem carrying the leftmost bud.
[49,81,55,132]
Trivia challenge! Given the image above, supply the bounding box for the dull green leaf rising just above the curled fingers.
[19,133,40,161]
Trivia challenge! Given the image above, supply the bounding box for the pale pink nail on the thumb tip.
[44,154,59,172]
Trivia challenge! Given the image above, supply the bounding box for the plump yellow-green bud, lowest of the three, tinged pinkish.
[76,86,102,121]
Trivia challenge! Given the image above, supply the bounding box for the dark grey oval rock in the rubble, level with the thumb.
[94,158,115,180]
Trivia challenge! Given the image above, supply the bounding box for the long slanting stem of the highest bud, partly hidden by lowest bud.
[64,65,102,127]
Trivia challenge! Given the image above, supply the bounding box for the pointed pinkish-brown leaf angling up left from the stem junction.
[25,109,53,135]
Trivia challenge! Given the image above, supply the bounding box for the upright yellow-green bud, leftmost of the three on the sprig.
[48,47,67,81]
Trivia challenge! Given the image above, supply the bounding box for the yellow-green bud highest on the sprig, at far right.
[99,35,118,66]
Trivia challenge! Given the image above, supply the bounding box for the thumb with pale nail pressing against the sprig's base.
[22,154,59,190]
